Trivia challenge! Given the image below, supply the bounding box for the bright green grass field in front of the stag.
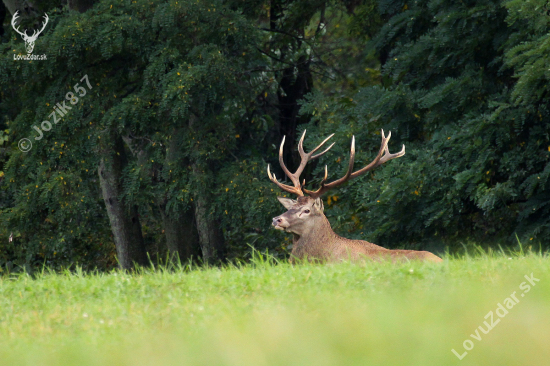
[0,253,550,366]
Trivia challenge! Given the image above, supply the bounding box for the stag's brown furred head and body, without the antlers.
[273,197,443,262]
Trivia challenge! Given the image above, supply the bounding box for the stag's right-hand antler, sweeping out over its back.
[304,130,405,198]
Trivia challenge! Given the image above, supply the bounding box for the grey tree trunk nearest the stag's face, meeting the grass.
[193,164,226,263]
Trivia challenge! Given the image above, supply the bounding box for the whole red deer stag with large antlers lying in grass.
[267,130,442,262]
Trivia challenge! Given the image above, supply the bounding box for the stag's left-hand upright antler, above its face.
[267,130,334,196]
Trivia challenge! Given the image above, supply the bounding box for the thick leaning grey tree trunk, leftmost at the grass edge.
[98,136,148,269]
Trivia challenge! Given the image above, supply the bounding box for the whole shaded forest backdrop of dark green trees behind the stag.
[0,0,550,270]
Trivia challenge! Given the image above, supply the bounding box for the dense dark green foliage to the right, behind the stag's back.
[304,1,550,246]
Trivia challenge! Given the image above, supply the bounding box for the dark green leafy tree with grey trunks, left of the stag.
[0,1,264,268]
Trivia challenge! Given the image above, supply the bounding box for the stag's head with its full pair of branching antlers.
[267,130,405,235]
